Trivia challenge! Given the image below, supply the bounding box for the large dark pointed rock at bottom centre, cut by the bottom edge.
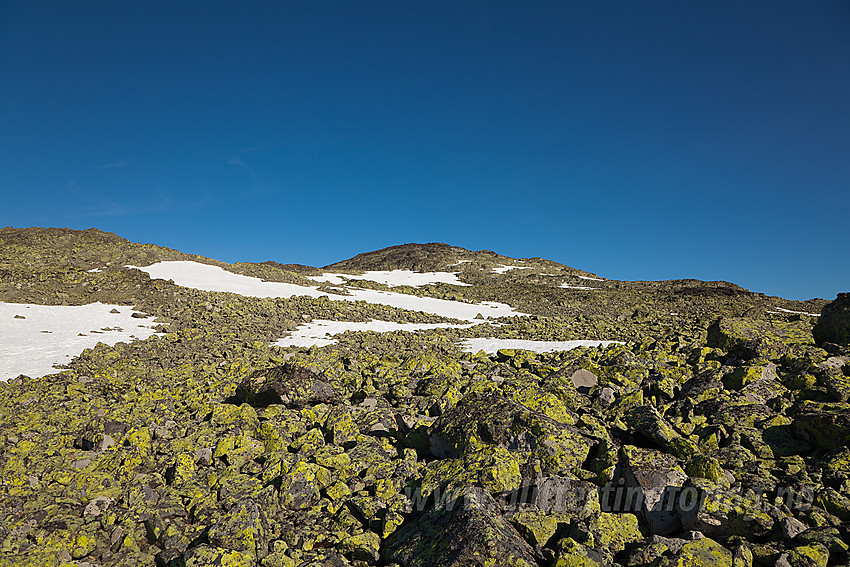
[384,487,540,567]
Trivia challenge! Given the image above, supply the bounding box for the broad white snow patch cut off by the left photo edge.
[0,303,156,381]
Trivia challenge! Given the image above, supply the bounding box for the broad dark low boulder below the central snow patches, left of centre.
[236,363,339,408]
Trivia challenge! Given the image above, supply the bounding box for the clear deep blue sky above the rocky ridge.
[0,0,850,299]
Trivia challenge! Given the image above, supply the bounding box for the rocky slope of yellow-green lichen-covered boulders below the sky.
[0,229,850,567]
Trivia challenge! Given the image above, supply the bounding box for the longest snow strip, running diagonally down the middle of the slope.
[127,260,526,322]
